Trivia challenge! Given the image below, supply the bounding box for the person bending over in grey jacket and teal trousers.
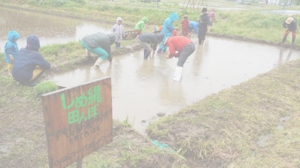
[81,32,116,68]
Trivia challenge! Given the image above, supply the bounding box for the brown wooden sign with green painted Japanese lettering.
[42,78,113,168]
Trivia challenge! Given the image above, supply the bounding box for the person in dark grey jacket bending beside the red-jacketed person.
[138,33,164,59]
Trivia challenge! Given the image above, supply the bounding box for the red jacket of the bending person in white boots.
[167,36,192,58]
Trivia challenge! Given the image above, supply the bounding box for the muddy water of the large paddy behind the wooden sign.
[51,37,300,133]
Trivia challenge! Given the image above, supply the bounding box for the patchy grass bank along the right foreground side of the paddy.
[147,60,300,167]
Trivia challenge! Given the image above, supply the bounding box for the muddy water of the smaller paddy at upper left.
[0,7,113,52]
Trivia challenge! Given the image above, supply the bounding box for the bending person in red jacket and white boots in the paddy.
[165,36,195,81]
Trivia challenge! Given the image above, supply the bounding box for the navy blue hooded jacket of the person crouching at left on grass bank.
[12,36,50,83]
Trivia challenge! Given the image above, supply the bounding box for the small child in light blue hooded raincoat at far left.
[4,30,20,75]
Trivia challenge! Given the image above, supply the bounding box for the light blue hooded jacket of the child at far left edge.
[4,30,20,63]
